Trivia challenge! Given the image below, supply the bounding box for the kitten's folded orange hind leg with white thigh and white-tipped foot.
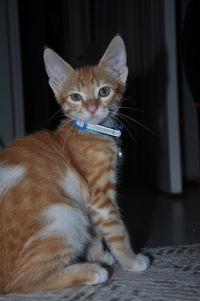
[4,204,108,293]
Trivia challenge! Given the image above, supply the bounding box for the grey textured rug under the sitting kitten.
[0,244,200,301]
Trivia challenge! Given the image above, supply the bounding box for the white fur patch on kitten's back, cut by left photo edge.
[0,165,26,195]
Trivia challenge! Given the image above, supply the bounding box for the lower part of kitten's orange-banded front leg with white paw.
[90,198,149,272]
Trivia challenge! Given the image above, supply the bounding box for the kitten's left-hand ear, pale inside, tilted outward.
[44,48,74,96]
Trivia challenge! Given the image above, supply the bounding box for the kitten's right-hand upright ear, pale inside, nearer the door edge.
[99,36,128,83]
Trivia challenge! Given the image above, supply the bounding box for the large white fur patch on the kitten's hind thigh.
[24,204,90,254]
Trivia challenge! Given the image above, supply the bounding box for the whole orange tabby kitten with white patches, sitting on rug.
[0,36,149,293]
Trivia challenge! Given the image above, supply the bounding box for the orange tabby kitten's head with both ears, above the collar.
[44,36,128,124]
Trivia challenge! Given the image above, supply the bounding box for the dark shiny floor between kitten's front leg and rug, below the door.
[118,186,200,251]
